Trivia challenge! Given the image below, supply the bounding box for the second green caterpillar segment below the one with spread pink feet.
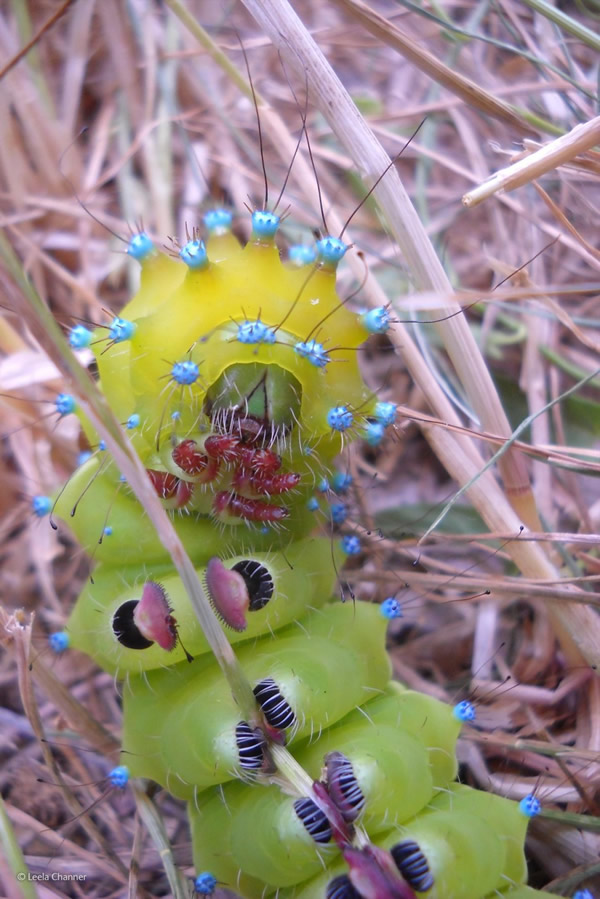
[189,693,460,896]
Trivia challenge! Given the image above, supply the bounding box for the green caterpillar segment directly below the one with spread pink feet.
[123,603,390,798]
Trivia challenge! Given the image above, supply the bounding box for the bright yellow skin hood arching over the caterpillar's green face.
[96,243,374,450]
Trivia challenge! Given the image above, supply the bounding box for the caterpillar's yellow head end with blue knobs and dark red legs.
[59,219,375,558]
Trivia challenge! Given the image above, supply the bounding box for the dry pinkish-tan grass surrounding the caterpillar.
[0,0,600,899]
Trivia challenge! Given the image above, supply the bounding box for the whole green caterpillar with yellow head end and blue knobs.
[43,204,564,899]
